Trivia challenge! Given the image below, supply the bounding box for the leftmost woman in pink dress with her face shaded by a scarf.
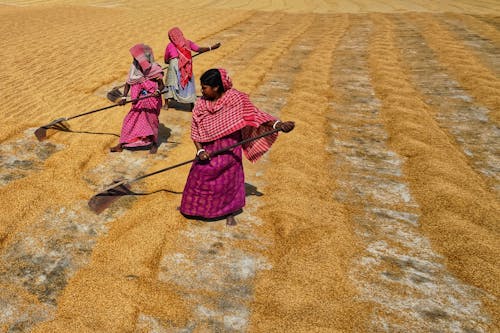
[110,44,164,154]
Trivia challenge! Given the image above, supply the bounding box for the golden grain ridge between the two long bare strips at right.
[378,13,500,304]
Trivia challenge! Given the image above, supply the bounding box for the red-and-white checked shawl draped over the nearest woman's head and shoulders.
[191,69,278,162]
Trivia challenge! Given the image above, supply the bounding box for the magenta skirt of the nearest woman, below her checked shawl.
[180,131,245,219]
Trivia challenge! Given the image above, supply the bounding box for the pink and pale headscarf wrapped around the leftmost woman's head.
[127,44,163,84]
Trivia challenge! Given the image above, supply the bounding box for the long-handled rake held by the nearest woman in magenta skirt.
[88,129,279,214]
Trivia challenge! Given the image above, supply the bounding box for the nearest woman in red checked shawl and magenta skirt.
[180,69,295,225]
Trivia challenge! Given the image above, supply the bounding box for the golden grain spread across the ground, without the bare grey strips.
[0,0,500,332]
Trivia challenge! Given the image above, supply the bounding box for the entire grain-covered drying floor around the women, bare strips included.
[0,0,500,332]
